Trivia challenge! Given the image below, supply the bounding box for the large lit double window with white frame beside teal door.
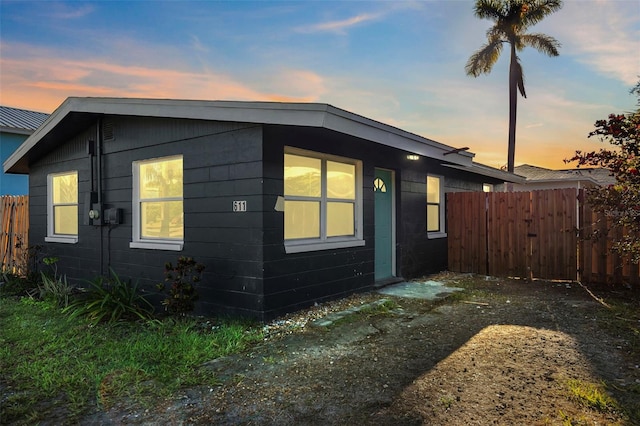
[284,148,364,253]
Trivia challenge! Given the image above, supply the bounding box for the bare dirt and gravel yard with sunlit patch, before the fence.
[85,274,640,425]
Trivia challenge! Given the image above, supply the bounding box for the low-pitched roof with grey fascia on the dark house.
[4,97,523,182]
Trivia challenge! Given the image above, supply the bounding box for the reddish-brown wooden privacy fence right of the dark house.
[447,189,640,284]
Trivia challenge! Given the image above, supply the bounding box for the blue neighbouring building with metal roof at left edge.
[0,106,49,195]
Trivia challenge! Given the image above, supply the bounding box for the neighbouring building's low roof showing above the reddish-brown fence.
[513,164,616,191]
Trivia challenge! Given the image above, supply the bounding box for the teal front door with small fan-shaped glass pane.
[373,169,394,281]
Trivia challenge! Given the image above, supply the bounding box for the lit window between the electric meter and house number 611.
[130,156,184,251]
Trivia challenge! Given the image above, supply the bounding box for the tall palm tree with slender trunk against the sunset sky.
[465,0,562,172]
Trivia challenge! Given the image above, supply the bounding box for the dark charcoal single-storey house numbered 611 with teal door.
[4,98,523,320]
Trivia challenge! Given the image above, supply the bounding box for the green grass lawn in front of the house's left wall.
[0,297,262,423]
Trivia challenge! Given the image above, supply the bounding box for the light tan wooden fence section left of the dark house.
[0,195,29,274]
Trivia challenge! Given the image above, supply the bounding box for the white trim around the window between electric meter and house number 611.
[129,155,184,251]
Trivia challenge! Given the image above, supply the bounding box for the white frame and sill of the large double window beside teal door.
[283,146,365,253]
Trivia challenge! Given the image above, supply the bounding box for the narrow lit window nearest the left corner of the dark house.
[45,171,78,243]
